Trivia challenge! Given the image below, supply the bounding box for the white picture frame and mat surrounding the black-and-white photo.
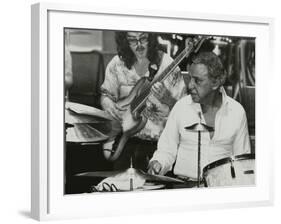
[31,3,274,220]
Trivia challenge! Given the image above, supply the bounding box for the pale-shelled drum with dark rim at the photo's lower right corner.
[203,154,255,187]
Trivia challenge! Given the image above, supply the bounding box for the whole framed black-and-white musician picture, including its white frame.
[31,3,273,220]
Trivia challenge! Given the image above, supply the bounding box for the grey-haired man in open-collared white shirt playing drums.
[148,52,250,179]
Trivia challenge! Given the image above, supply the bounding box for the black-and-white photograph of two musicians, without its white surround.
[64,27,256,195]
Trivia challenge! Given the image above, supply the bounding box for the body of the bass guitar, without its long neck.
[103,78,149,161]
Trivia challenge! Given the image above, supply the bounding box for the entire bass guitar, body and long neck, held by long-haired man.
[103,37,205,161]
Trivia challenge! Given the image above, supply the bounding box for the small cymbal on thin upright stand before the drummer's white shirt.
[185,112,214,188]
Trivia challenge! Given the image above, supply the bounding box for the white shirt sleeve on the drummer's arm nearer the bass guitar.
[151,107,179,174]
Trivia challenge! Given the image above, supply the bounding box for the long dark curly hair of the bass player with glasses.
[115,31,161,69]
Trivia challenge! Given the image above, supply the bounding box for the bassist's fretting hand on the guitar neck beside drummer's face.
[151,82,176,108]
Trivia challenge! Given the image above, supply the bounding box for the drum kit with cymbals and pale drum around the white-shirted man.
[65,102,255,191]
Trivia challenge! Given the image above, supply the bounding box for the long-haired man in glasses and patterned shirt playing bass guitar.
[101,32,185,170]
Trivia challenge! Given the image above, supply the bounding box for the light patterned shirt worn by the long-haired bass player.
[101,54,185,140]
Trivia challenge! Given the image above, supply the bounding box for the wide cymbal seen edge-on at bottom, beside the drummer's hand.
[76,168,184,183]
